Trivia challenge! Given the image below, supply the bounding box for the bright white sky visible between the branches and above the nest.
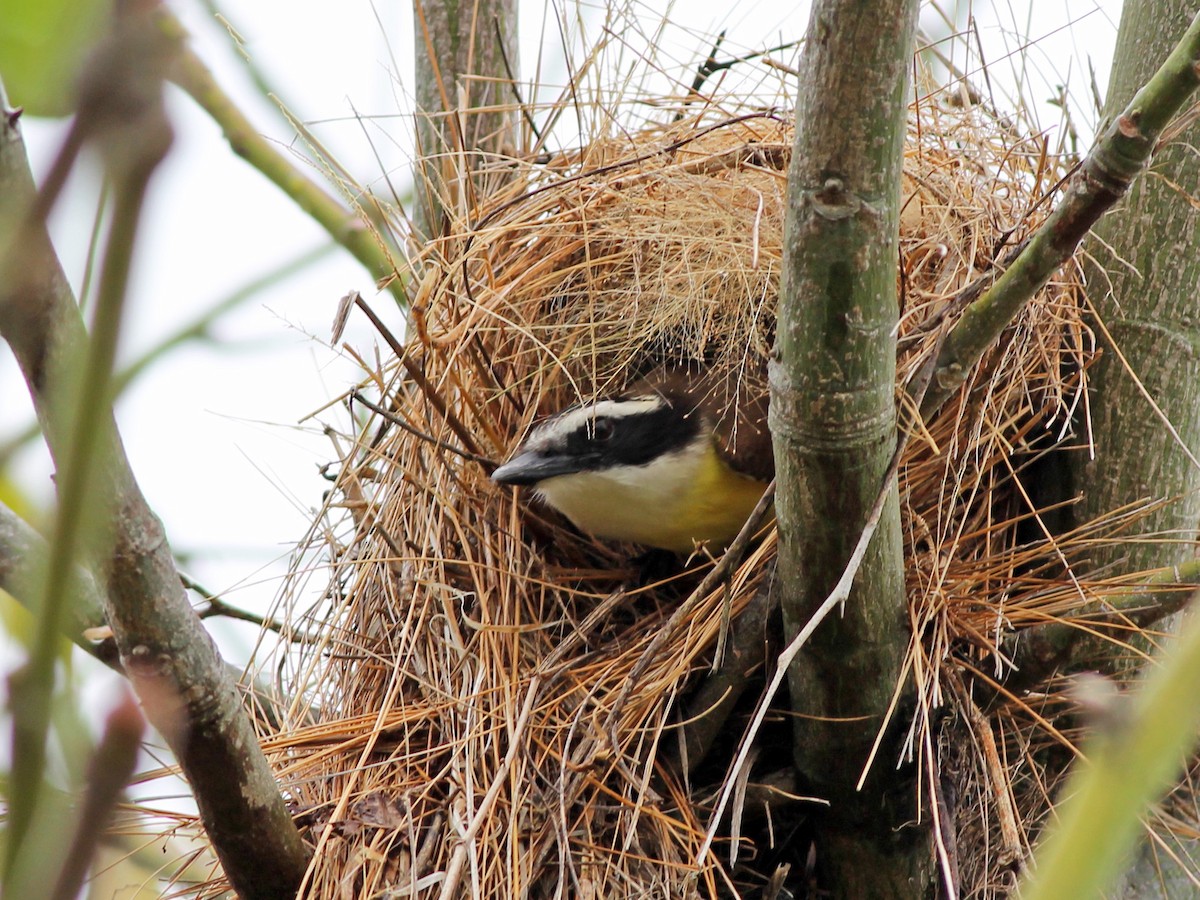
[0,0,1120,671]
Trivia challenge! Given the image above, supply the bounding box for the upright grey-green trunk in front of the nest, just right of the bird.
[770,0,931,898]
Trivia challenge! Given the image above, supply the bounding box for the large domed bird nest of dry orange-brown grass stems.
[243,90,1123,898]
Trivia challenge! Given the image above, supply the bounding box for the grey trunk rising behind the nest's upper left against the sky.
[413,0,517,240]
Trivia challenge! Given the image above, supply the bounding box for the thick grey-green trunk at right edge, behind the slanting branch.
[1067,0,1200,898]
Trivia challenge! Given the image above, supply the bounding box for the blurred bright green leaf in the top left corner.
[0,0,112,116]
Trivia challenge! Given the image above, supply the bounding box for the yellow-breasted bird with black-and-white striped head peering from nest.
[492,372,774,553]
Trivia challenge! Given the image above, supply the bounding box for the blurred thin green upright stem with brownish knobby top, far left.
[0,7,173,868]
